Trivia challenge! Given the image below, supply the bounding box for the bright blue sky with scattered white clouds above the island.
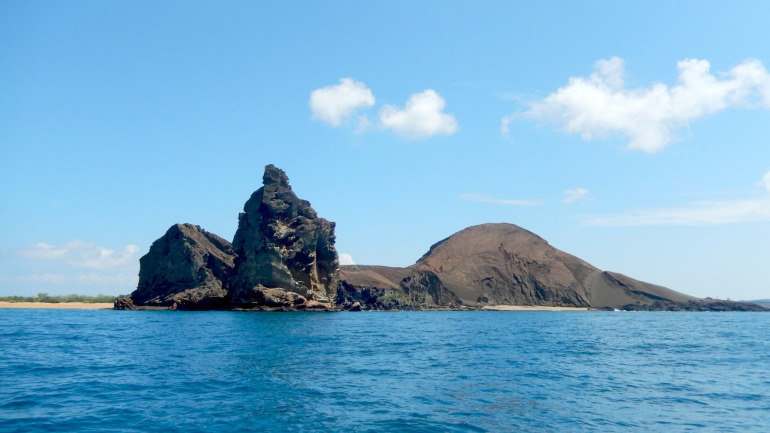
[0,1,770,299]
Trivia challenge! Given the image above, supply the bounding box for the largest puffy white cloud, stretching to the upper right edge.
[510,57,770,153]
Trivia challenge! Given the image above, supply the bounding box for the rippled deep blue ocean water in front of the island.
[0,309,770,433]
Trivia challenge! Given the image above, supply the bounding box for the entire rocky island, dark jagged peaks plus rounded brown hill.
[115,165,766,311]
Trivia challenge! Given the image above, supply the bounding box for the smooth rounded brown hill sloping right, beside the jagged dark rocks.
[338,224,760,310]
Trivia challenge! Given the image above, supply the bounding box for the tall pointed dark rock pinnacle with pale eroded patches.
[231,165,339,306]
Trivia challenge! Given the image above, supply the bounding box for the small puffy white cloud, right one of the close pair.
[379,89,457,140]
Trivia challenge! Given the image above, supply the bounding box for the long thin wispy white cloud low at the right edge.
[585,172,770,226]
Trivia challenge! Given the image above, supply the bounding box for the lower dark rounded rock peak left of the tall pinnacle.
[131,224,235,309]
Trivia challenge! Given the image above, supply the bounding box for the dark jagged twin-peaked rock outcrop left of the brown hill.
[115,165,339,310]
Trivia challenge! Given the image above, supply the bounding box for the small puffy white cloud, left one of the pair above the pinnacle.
[310,78,374,129]
